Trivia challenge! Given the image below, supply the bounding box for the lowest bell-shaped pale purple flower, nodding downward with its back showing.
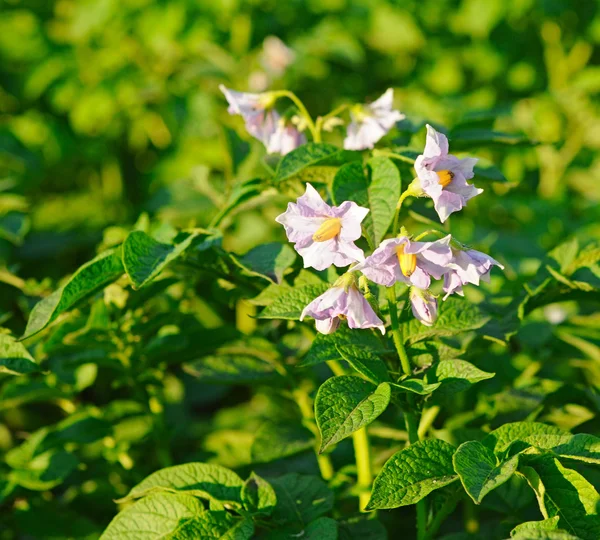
[300,273,385,334]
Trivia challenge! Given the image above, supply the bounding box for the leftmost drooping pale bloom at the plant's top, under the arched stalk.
[219,85,306,155]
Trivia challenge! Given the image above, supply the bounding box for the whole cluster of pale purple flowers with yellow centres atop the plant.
[221,87,503,334]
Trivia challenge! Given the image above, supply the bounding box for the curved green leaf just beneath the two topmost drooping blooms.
[273,143,359,184]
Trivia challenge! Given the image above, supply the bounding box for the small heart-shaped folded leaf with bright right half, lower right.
[452,441,519,504]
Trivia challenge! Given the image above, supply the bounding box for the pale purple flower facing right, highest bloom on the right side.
[415,124,483,223]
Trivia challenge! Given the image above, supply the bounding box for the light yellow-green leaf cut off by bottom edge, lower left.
[100,493,204,540]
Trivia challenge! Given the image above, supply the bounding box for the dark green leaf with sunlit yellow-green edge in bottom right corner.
[519,454,600,540]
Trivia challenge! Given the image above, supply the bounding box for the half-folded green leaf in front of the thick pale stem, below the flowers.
[315,375,391,452]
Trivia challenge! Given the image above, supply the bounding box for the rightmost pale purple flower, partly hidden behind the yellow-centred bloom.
[444,249,504,300]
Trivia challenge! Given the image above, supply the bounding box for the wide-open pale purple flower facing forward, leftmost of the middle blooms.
[275,184,369,270]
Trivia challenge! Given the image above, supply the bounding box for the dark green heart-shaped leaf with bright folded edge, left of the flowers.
[123,231,200,289]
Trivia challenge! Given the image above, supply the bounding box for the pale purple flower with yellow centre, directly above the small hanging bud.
[353,235,452,289]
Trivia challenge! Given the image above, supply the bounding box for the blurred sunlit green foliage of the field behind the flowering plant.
[0,0,600,540]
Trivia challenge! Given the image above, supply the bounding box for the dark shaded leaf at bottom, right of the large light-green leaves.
[269,473,333,529]
